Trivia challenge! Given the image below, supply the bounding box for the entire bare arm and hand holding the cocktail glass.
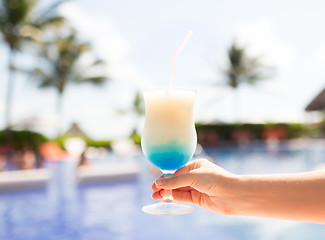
[152,159,325,224]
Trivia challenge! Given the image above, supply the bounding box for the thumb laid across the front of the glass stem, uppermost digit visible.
[155,172,194,189]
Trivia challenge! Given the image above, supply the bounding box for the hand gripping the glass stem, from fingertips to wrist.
[152,159,236,214]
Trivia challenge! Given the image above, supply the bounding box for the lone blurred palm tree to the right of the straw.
[223,41,274,121]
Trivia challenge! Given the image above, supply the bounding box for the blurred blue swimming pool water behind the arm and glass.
[0,144,325,240]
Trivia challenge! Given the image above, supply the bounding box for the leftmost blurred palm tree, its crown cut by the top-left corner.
[0,0,64,128]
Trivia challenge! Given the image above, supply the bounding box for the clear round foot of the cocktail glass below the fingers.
[142,201,193,215]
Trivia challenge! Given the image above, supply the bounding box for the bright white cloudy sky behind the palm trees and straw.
[0,0,325,139]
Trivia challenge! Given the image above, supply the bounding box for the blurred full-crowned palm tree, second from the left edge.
[27,30,108,134]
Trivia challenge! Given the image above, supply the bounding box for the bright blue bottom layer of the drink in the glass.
[146,144,193,170]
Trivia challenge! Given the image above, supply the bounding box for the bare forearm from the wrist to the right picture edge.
[229,171,325,223]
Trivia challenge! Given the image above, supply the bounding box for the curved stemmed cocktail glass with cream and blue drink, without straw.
[141,89,197,215]
